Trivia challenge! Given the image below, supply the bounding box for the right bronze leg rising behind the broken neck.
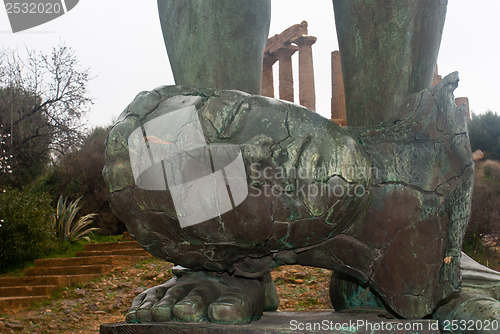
[333,0,447,126]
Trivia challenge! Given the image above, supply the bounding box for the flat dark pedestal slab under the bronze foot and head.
[100,310,439,334]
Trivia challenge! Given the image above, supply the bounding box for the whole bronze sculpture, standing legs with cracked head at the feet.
[103,0,498,323]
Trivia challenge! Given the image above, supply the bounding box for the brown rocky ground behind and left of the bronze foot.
[0,259,331,334]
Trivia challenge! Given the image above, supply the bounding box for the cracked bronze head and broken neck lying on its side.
[104,74,473,317]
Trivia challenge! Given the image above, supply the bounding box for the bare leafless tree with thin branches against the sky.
[0,44,92,187]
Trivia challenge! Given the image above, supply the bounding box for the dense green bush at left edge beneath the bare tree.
[0,189,57,272]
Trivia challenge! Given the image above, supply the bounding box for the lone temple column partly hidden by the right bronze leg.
[332,51,347,126]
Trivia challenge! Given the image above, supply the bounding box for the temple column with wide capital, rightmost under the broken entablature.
[295,36,316,111]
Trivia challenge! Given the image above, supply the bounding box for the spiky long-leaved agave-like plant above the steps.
[52,195,99,242]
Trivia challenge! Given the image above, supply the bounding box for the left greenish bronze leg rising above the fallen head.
[158,0,271,94]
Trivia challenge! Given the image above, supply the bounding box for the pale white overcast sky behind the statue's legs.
[0,0,500,125]
